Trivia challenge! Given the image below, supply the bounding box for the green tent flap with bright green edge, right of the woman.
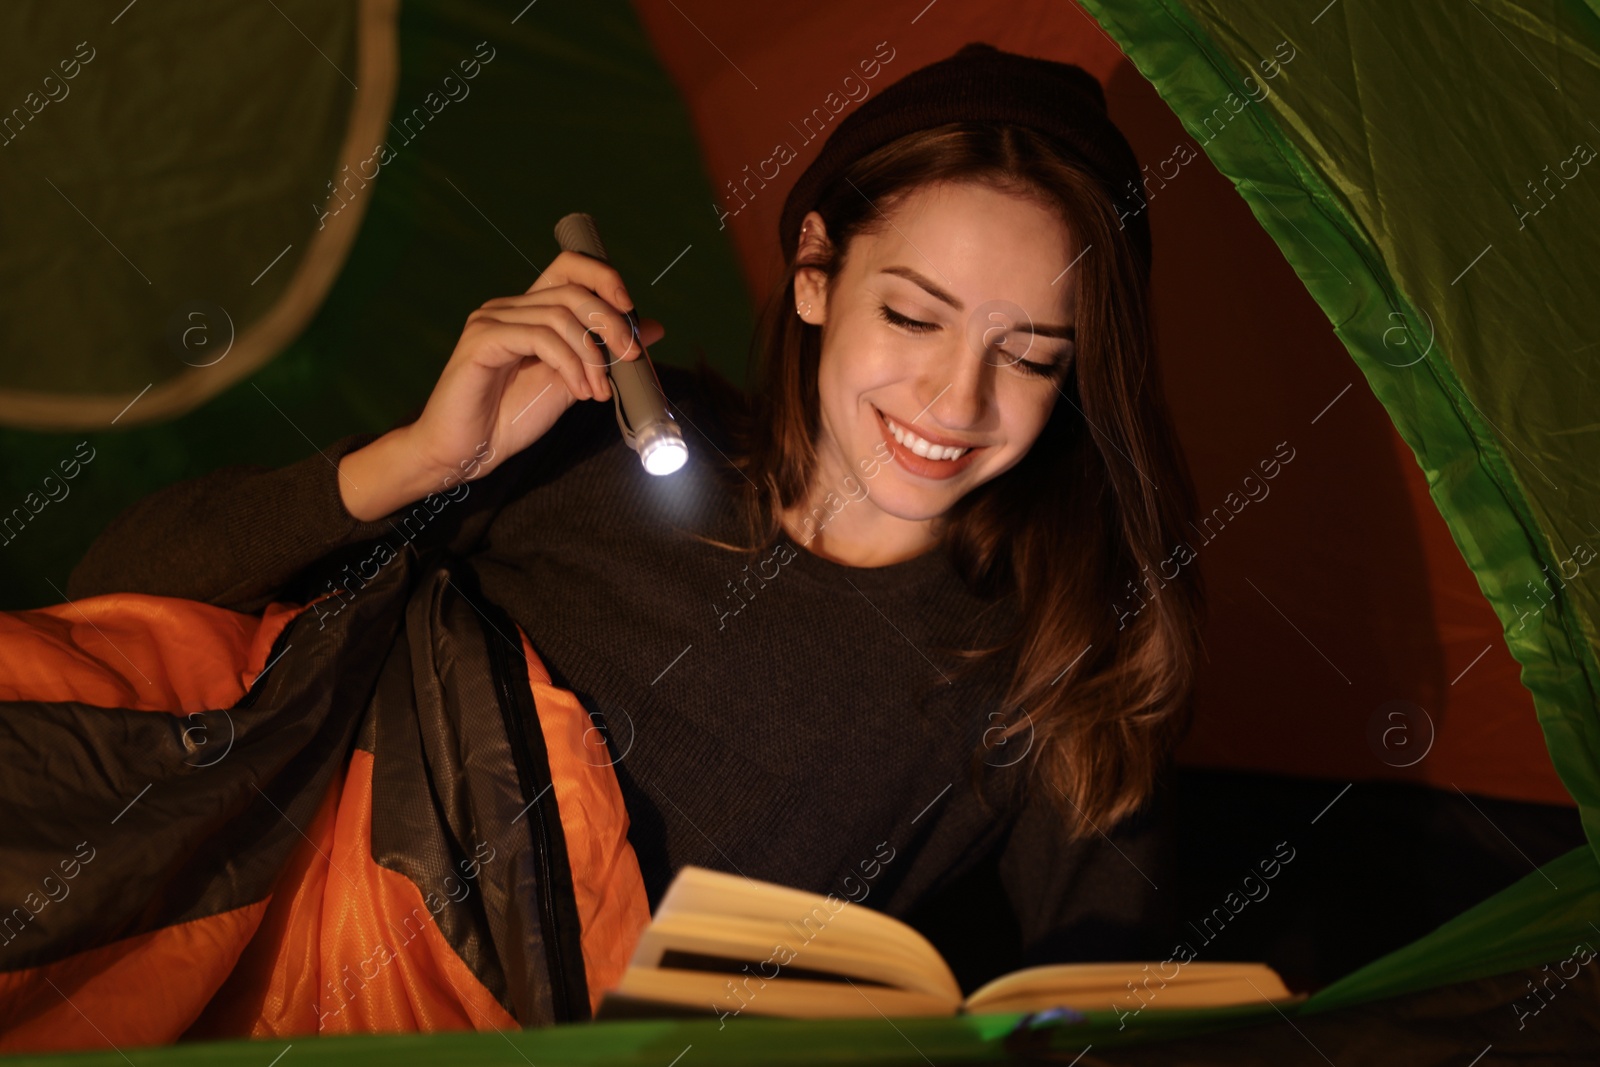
[1086,0,1600,1011]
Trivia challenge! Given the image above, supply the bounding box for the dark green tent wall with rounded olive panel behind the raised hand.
[0,0,754,609]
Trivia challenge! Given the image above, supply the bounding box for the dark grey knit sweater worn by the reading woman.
[69,366,1173,963]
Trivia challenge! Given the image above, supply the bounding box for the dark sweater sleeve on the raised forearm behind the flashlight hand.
[67,434,406,611]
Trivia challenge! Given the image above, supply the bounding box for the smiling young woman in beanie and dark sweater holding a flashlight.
[70,46,1202,963]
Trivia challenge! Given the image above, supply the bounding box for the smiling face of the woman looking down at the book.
[795,182,1078,536]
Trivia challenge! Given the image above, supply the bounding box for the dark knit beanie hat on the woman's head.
[778,42,1150,266]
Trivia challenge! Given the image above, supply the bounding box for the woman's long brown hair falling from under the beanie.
[684,123,1205,837]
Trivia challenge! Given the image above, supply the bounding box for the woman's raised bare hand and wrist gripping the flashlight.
[339,251,666,520]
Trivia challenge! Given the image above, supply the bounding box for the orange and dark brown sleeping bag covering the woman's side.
[0,545,650,1053]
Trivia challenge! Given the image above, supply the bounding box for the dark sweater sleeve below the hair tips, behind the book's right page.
[1000,776,1178,966]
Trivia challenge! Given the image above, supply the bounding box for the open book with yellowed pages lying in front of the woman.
[595,867,1302,1019]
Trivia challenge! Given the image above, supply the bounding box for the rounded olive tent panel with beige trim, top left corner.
[0,0,385,428]
